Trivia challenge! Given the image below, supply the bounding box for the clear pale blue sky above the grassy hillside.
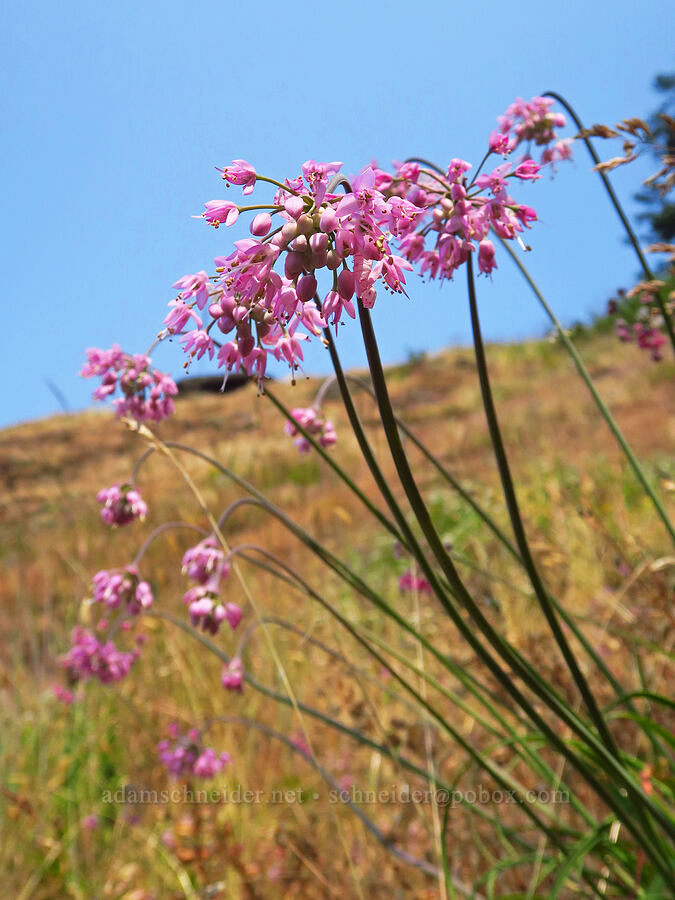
[0,0,675,425]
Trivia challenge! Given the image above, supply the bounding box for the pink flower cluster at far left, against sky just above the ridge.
[80,344,178,422]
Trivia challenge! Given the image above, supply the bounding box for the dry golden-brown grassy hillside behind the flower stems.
[0,336,675,900]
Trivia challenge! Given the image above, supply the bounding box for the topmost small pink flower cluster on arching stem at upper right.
[489,97,572,165]
